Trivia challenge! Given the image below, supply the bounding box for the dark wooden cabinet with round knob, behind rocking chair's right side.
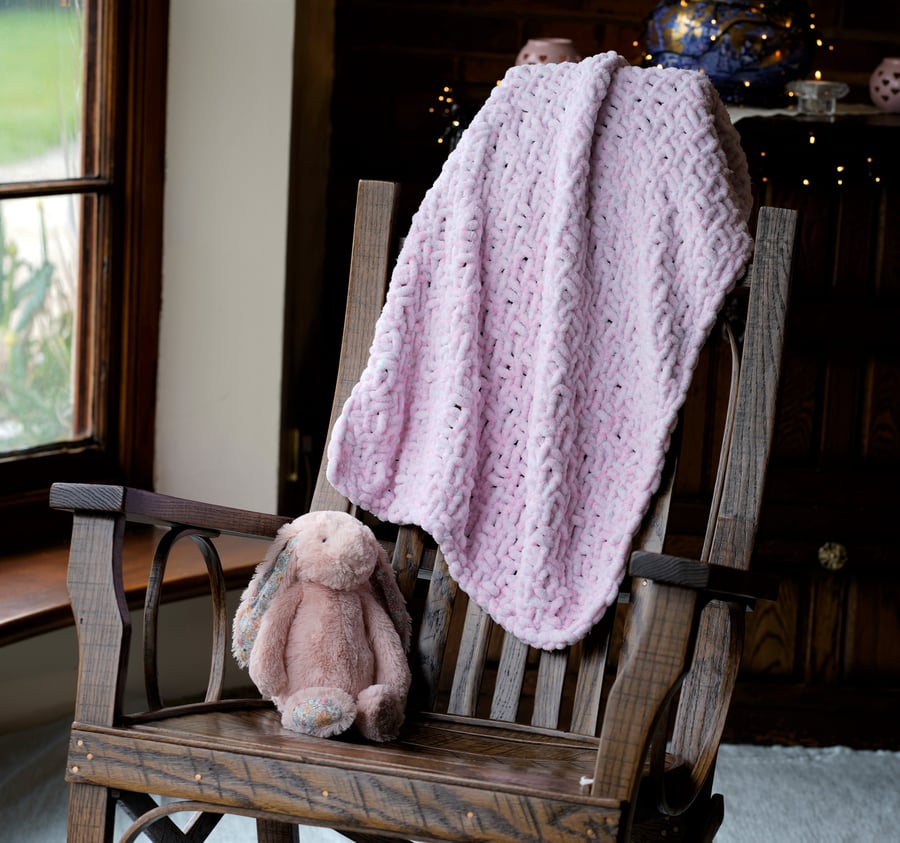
[729,115,900,748]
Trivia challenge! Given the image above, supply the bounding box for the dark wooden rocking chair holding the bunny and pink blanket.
[51,182,795,843]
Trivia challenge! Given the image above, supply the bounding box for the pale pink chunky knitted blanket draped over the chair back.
[328,53,751,649]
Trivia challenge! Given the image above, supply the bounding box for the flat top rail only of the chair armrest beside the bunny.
[50,483,291,538]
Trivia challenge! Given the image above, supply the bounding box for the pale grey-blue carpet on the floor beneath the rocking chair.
[0,723,900,843]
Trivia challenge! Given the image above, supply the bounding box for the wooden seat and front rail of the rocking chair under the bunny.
[68,708,621,843]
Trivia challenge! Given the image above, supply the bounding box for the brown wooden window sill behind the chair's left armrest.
[0,526,267,646]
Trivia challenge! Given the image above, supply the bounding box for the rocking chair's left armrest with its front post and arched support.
[50,483,290,726]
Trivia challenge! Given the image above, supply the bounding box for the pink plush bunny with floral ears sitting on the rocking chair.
[234,511,410,741]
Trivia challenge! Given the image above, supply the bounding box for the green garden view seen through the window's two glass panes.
[0,0,83,457]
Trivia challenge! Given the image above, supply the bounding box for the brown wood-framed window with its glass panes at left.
[0,0,168,546]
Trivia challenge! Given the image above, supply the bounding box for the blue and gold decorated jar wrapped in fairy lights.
[645,0,816,106]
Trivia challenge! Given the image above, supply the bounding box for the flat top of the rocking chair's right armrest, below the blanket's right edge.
[628,550,778,604]
